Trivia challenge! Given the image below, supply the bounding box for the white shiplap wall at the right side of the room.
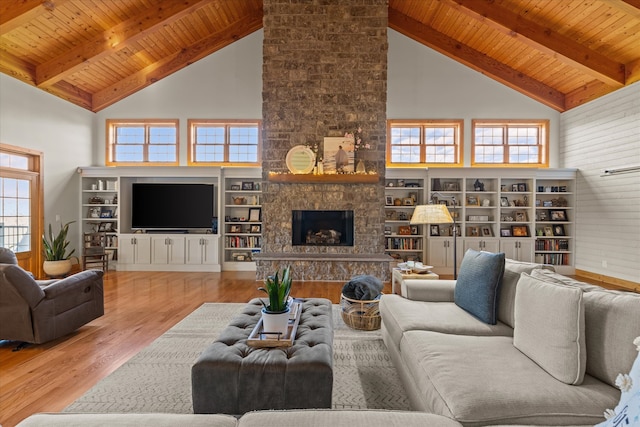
[560,82,640,283]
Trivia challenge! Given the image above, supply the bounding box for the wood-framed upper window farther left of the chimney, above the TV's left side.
[106,120,179,166]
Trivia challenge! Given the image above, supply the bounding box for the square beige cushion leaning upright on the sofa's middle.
[513,273,587,385]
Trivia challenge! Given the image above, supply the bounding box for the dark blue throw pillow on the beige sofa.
[453,249,505,325]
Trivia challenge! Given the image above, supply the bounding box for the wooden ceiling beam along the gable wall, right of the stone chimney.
[389,8,565,111]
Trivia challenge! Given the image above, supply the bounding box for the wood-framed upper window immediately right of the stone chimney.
[387,120,463,167]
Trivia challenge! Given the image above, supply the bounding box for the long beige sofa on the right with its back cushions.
[380,251,640,426]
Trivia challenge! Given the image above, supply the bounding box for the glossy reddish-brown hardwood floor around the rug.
[0,271,632,427]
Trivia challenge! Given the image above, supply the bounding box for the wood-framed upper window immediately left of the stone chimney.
[188,120,262,166]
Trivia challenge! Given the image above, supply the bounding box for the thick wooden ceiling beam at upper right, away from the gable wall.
[444,0,625,88]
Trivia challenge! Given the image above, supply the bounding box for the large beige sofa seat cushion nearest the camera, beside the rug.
[400,331,620,426]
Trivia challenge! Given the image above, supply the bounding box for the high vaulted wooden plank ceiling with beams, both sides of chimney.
[0,0,640,112]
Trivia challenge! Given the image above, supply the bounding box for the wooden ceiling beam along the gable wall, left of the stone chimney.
[91,10,262,112]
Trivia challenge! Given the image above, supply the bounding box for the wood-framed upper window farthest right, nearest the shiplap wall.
[471,120,549,167]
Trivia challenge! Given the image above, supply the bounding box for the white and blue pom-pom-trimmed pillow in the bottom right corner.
[596,337,640,427]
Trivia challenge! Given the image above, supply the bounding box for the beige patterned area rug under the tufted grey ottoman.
[63,303,409,413]
